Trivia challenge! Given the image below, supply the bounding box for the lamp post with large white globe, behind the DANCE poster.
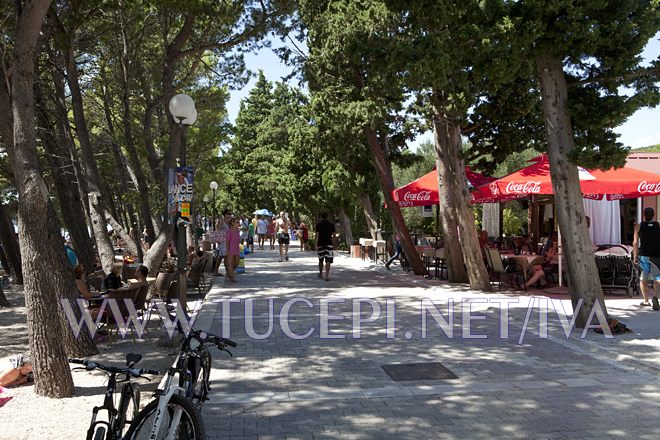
[168,94,197,302]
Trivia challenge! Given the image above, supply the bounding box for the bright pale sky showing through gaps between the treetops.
[227,32,660,149]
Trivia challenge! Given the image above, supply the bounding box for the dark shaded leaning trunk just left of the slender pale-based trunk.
[35,85,96,271]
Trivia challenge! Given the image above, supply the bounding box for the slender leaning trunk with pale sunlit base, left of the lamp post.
[66,42,114,273]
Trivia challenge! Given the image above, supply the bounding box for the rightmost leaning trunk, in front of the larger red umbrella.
[536,55,607,328]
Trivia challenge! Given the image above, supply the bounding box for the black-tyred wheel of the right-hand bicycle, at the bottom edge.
[124,394,206,440]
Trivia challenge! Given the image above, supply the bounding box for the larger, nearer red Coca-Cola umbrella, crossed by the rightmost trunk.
[472,154,660,203]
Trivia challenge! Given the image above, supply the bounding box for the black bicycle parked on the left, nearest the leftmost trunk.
[69,353,160,440]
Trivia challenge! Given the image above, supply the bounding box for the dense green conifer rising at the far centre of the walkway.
[220,73,326,218]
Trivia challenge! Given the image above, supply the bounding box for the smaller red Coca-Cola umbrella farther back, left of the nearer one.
[392,167,495,207]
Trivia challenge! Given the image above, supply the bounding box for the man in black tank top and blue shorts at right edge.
[633,207,660,311]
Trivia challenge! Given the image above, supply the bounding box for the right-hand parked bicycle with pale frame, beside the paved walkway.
[126,330,236,440]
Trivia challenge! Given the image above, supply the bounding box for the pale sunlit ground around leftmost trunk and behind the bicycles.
[0,282,209,440]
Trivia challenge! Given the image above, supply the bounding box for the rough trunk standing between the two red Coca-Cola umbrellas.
[433,91,491,292]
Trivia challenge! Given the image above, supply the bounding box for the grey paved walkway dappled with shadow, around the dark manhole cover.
[198,250,660,440]
